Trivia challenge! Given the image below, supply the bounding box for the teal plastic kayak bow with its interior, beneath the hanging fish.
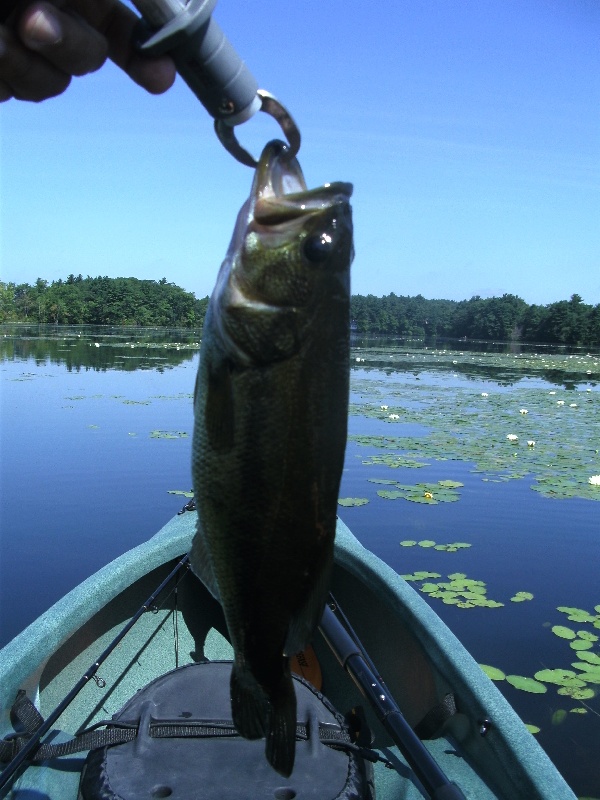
[0,511,575,800]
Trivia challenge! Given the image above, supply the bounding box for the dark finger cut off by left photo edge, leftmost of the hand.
[0,26,71,102]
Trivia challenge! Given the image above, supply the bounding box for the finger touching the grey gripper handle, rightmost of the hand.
[71,0,176,94]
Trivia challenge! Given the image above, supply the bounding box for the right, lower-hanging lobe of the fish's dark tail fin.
[265,670,296,778]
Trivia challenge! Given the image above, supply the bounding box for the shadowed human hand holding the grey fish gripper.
[0,0,175,102]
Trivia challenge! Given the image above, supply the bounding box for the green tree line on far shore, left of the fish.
[0,275,208,328]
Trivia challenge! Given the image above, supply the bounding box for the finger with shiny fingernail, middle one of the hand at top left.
[19,2,108,75]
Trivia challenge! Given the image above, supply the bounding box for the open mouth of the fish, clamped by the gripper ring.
[251,140,352,226]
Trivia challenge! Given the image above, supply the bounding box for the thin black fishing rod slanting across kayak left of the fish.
[0,555,189,789]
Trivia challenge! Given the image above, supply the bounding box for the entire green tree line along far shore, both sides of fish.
[0,275,600,346]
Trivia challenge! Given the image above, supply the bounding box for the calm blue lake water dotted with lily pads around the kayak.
[0,326,600,797]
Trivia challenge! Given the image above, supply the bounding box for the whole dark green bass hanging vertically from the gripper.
[190,140,354,777]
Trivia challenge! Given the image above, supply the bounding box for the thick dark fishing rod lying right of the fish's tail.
[319,595,466,800]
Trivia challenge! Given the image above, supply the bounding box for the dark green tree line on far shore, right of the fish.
[351,293,600,346]
